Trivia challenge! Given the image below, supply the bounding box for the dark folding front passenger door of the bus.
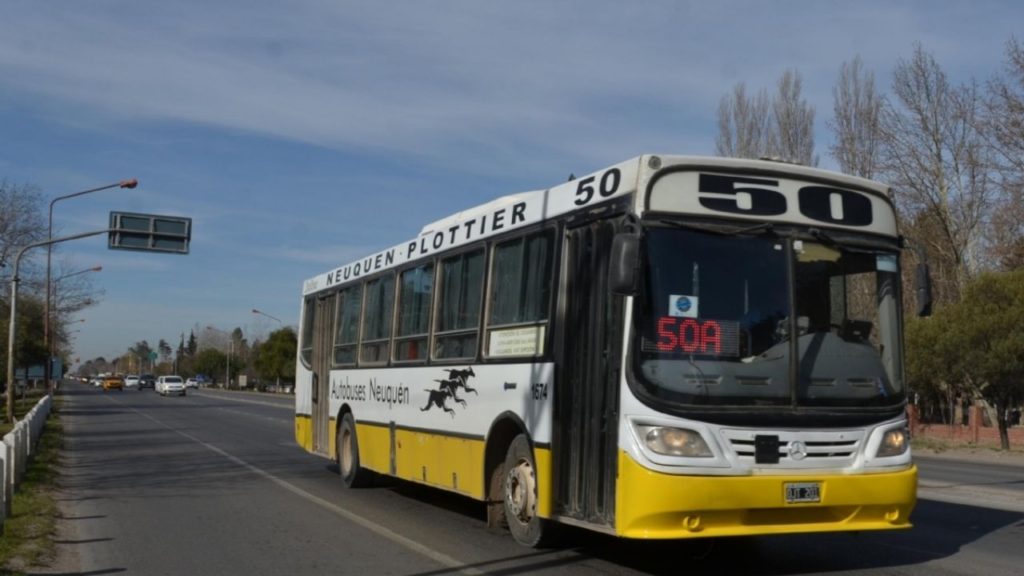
[552,219,623,526]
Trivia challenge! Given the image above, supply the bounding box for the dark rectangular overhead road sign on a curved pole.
[108,212,191,254]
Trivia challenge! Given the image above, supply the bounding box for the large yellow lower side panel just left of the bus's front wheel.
[393,428,484,499]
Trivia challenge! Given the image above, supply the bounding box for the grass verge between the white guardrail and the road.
[0,397,63,575]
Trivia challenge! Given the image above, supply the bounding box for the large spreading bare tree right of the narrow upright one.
[880,45,994,301]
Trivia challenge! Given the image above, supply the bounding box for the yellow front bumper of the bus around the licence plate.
[615,451,918,539]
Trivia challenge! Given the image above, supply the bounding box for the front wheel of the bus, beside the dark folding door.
[502,434,552,547]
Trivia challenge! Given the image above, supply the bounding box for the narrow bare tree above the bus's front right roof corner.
[828,56,884,178]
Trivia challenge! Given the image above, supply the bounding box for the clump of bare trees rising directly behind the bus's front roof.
[715,70,817,166]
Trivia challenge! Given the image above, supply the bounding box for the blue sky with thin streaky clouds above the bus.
[0,0,1024,361]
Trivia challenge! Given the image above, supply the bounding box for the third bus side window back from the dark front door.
[394,262,434,362]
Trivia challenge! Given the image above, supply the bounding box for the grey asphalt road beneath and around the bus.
[32,384,1024,576]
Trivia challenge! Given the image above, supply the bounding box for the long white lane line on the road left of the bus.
[129,408,485,576]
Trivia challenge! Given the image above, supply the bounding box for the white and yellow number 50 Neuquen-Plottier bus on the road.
[295,155,928,546]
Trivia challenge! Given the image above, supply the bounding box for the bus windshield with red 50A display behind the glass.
[634,227,904,409]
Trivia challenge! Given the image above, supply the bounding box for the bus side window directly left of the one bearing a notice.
[434,249,484,360]
